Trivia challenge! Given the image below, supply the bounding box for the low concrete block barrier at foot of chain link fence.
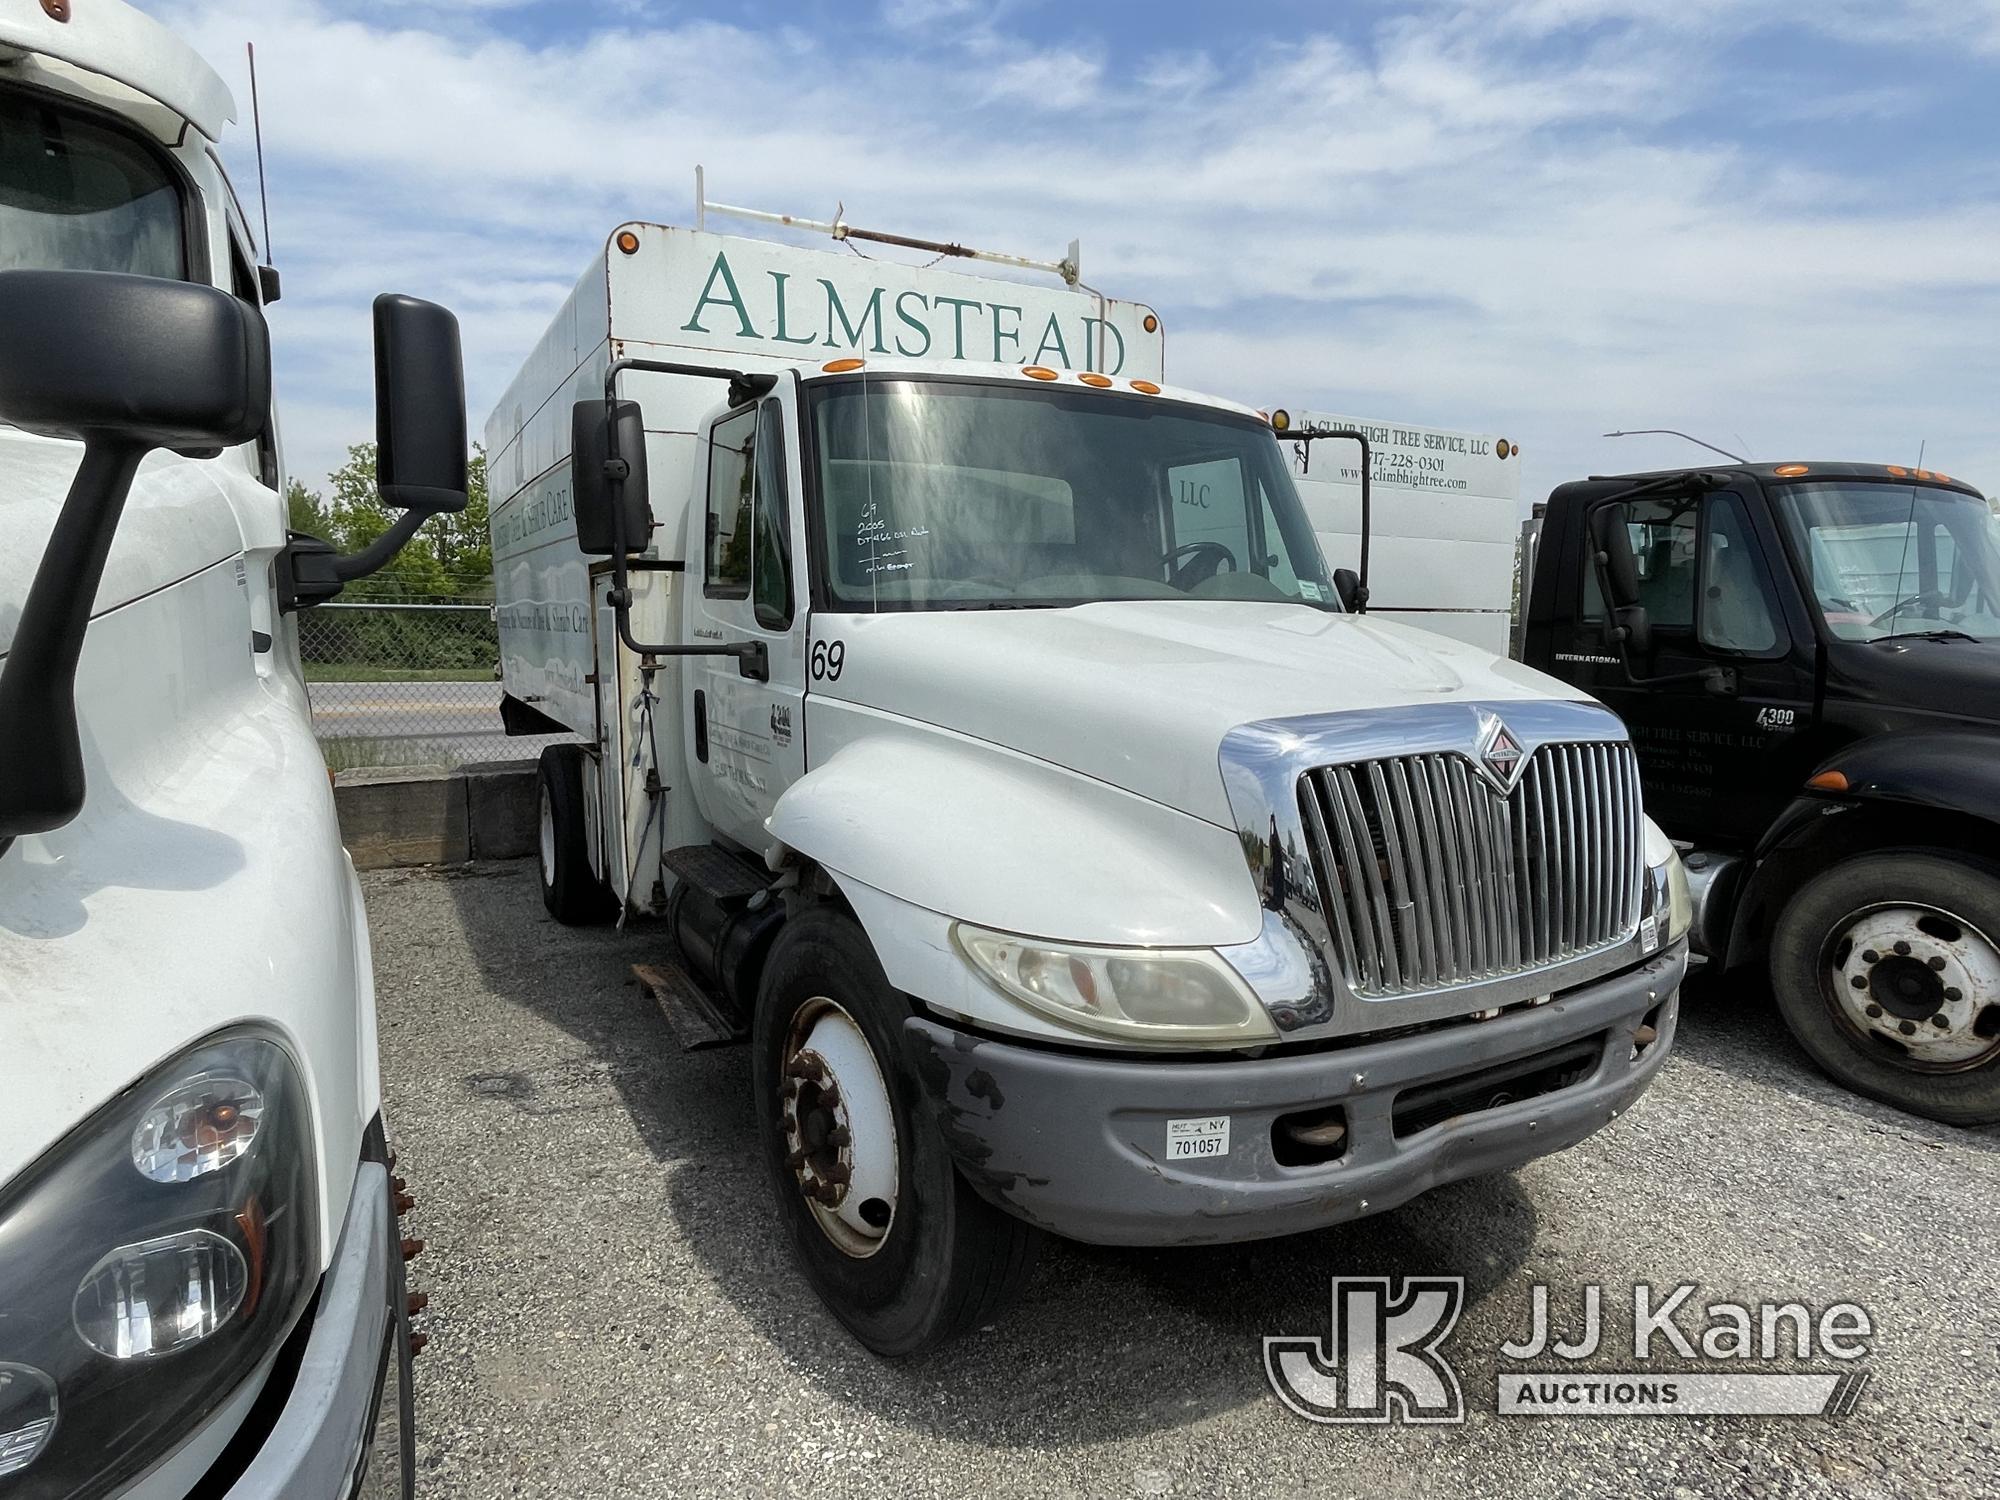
[334,760,540,870]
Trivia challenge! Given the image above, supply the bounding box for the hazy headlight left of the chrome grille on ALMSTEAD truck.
[952,922,1278,1046]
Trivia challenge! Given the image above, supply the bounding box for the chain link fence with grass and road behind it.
[298,600,572,770]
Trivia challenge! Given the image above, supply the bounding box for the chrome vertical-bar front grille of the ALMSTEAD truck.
[1298,740,1644,998]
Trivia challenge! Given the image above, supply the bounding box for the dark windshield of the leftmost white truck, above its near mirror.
[0,90,188,280]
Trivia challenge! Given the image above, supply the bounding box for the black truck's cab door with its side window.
[1554,484,1816,848]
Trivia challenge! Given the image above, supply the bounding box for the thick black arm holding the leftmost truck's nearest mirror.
[0,436,146,854]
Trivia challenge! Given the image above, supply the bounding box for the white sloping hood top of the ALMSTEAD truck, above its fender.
[808,600,1584,828]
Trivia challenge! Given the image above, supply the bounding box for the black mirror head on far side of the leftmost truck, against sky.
[374,292,466,516]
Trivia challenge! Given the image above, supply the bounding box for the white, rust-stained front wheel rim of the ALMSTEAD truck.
[778,996,898,1260]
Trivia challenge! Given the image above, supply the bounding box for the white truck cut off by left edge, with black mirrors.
[0,0,466,1500]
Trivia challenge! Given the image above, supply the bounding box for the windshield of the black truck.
[1778,484,2000,640]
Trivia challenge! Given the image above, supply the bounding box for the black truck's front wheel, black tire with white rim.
[1770,850,2000,1124]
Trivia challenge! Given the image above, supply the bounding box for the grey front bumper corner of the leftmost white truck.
[228,1162,410,1500]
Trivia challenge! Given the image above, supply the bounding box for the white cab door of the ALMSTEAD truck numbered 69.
[686,382,806,852]
